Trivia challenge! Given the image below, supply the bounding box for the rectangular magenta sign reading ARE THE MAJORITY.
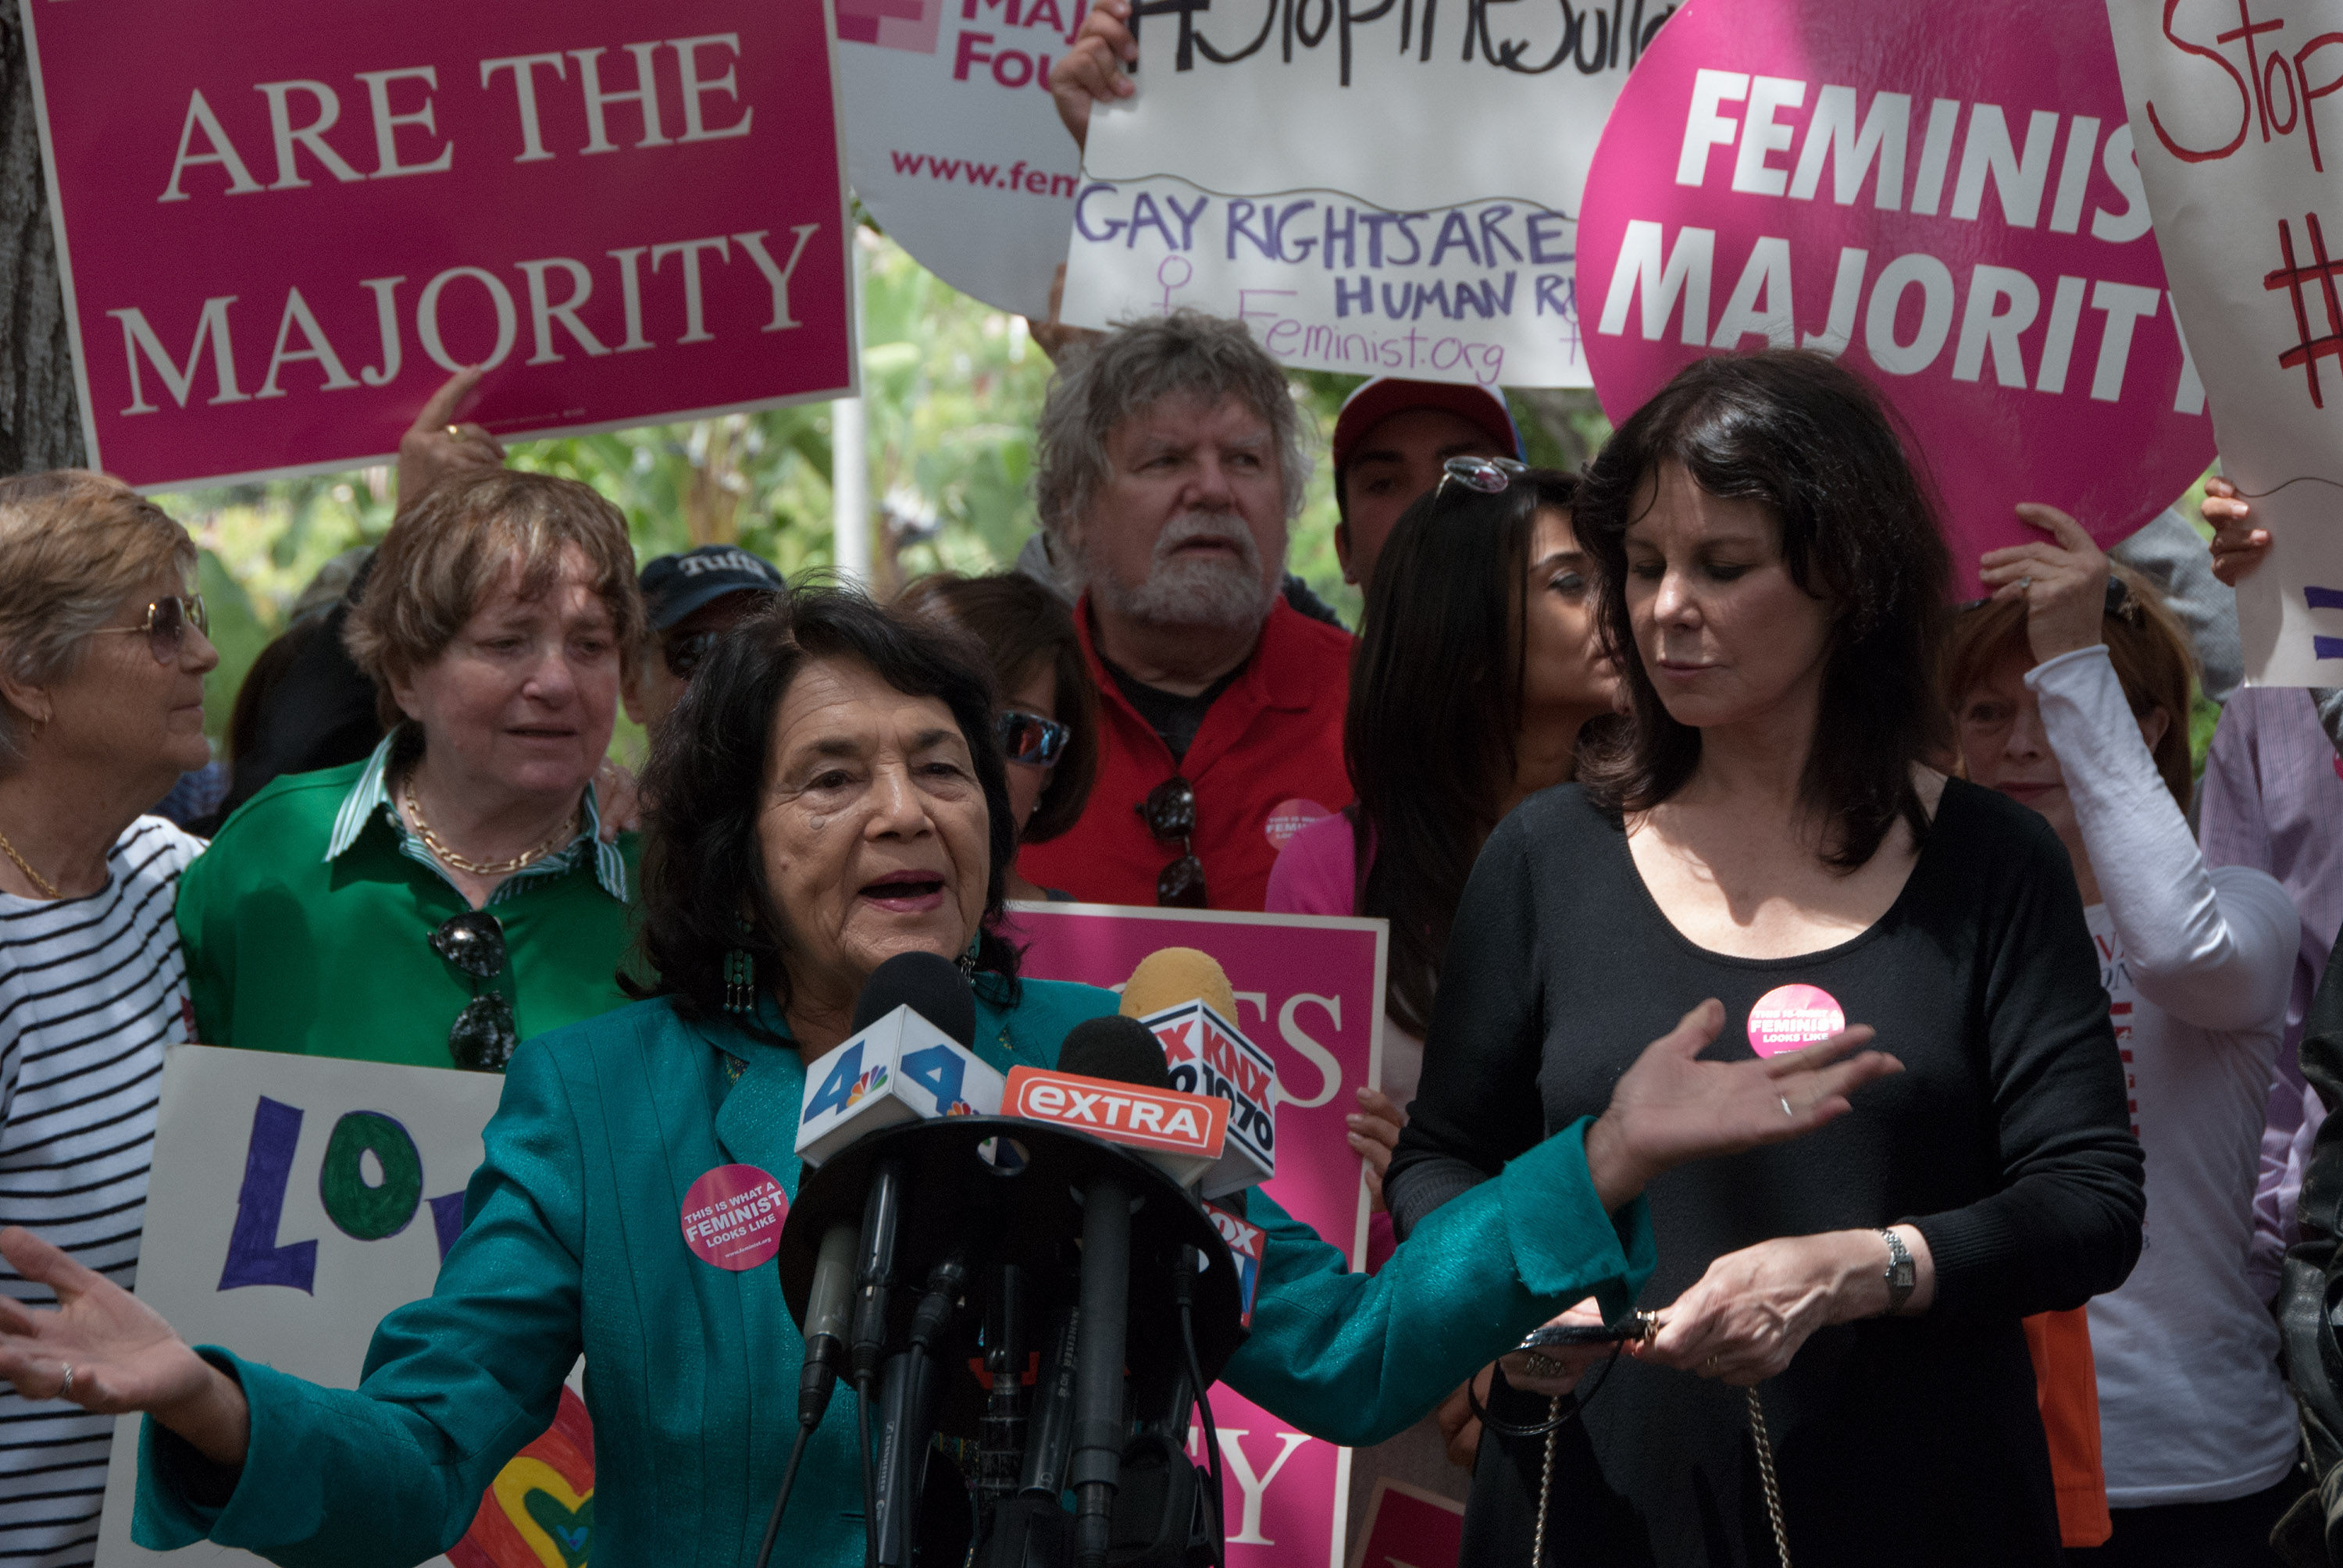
[26,0,853,487]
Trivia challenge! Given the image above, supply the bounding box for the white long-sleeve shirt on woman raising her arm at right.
[2027,647,2301,1507]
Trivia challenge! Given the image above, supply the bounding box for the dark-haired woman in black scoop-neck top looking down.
[1385,351,2144,1568]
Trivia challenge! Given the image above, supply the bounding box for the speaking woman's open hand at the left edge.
[0,1226,251,1465]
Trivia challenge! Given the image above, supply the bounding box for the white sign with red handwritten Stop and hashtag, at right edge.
[2106,0,2343,686]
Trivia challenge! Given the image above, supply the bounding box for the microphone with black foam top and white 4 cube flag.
[797,952,1005,1167]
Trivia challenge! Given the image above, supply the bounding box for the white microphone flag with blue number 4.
[797,1006,1007,1165]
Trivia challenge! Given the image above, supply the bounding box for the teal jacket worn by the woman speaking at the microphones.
[134,980,1652,1568]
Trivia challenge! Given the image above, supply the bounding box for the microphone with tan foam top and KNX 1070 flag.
[1120,947,1277,1198]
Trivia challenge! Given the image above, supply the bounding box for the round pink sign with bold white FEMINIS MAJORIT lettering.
[1577,0,2212,590]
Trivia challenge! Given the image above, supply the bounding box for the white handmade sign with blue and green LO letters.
[98,1046,593,1568]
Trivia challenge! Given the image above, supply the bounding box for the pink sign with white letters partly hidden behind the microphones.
[1010,905,1387,1568]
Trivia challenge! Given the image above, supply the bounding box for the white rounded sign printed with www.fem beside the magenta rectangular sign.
[839,0,1087,319]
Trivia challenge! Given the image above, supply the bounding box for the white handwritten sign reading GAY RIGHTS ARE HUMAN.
[1064,0,1675,387]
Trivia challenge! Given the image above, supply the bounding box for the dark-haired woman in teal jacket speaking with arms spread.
[0,593,1893,1568]
